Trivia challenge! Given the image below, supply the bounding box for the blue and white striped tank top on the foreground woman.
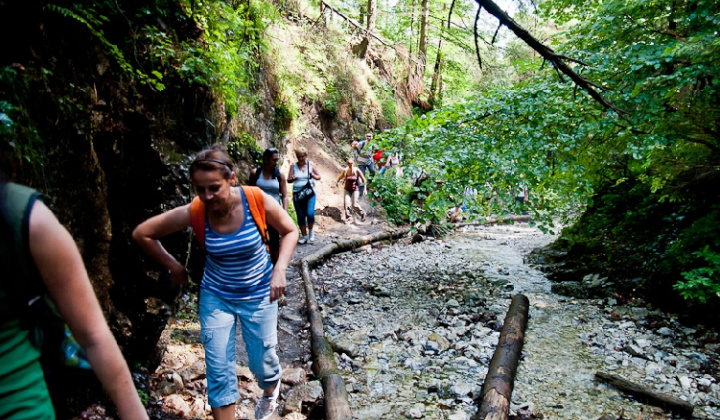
[200,188,273,302]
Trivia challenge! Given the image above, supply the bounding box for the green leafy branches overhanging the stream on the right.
[376,0,720,308]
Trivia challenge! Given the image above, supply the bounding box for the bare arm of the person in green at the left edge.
[29,202,148,420]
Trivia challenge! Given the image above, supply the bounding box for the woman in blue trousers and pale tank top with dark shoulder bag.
[287,146,320,244]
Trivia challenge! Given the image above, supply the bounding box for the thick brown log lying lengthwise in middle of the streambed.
[473,295,530,420]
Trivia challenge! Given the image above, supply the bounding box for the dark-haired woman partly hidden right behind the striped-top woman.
[250,147,288,264]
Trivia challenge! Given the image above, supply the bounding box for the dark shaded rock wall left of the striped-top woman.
[0,2,212,368]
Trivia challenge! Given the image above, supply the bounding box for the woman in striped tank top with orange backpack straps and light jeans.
[133,144,298,420]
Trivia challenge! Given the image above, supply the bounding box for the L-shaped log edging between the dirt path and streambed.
[300,229,409,420]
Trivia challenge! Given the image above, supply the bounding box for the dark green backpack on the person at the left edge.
[0,183,91,374]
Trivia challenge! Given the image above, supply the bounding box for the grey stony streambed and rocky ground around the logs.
[141,224,720,420]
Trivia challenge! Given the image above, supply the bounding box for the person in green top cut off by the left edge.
[0,181,148,420]
